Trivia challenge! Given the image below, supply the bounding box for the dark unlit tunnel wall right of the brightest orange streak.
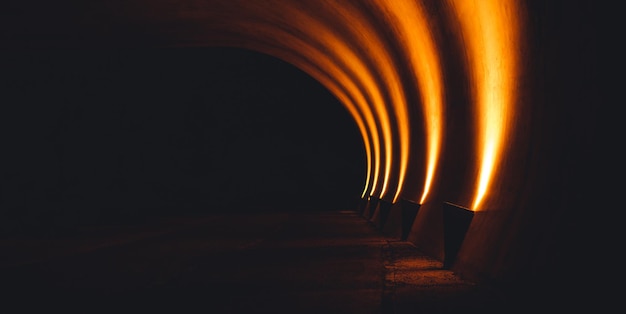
[448,2,606,291]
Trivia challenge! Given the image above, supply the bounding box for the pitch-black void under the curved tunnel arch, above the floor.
[0,48,365,234]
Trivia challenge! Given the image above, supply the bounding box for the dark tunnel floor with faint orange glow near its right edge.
[0,211,517,313]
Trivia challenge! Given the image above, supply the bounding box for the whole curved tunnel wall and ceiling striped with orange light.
[0,0,602,302]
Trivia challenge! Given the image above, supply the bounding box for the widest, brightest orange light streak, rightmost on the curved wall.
[451,0,519,210]
